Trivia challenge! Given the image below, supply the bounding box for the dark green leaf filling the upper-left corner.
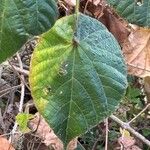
[0,0,58,63]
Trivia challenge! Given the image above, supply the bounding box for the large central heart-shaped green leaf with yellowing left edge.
[30,14,126,144]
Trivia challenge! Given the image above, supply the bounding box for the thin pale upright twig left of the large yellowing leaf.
[9,53,25,141]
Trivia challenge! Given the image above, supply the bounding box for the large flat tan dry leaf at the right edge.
[123,28,150,77]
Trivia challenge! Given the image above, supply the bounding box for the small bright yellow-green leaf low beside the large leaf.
[16,113,33,133]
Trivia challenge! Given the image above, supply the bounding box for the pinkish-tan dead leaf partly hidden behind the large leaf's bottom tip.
[29,113,77,150]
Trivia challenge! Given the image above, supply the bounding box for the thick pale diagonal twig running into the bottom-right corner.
[110,115,150,146]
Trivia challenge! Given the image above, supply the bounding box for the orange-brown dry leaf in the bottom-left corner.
[0,137,15,150]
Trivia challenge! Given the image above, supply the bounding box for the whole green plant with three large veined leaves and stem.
[0,0,150,146]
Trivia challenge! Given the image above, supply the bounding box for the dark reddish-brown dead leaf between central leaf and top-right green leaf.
[82,0,130,45]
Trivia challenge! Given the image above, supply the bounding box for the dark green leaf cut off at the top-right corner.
[107,0,150,27]
